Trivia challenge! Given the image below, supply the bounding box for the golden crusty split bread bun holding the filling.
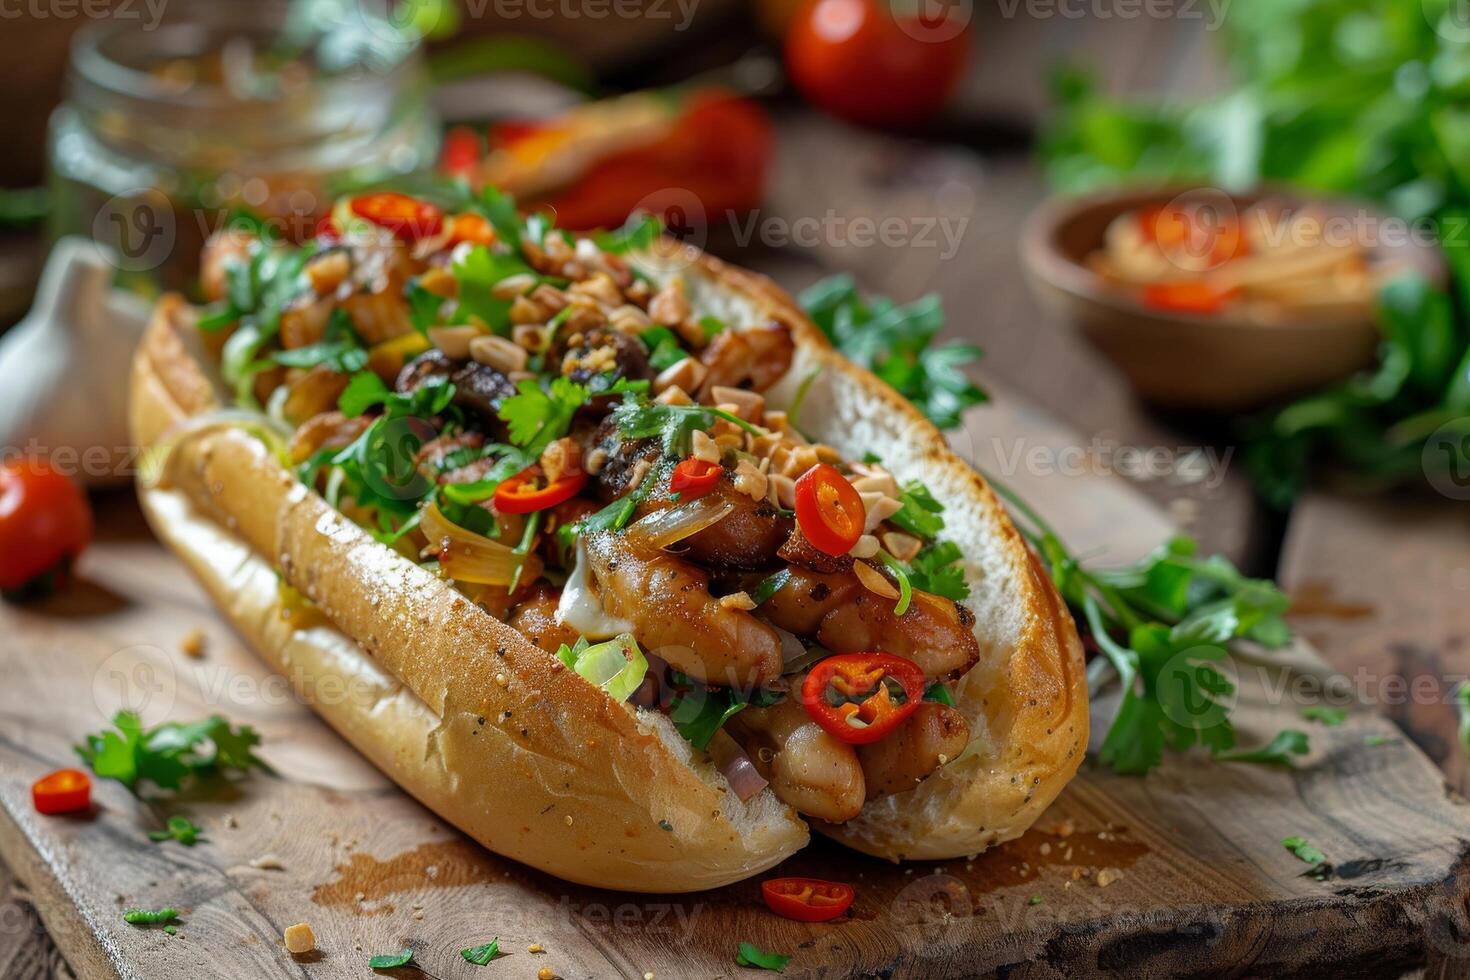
[131,239,1088,892]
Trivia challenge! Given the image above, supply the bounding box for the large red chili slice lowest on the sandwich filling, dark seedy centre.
[801,652,925,745]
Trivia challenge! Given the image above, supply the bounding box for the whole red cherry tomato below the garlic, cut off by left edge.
[0,458,93,594]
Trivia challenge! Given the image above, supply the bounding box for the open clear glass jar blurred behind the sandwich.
[50,0,440,297]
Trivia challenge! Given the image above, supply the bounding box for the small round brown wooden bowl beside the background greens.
[1022,187,1445,413]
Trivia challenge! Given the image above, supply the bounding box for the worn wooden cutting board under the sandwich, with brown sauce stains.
[0,398,1470,980]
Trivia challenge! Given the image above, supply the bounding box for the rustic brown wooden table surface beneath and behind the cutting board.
[0,13,1470,980]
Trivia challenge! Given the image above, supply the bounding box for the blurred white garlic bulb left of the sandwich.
[0,238,147,486]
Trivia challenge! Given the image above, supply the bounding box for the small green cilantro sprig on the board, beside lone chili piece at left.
[74,711,269,792]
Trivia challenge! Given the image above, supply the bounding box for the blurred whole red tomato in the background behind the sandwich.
[786,0,970,125]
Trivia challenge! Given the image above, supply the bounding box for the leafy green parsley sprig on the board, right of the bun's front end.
[991,480,1307,774]
